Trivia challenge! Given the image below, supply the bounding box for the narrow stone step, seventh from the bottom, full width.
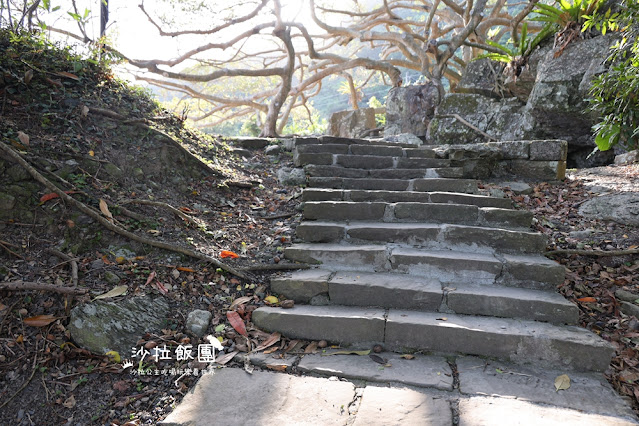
[308,177,478,194]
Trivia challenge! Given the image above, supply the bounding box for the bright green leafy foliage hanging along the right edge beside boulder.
[589,0,639,151]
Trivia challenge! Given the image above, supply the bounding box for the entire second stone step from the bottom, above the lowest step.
[271,269,579,324]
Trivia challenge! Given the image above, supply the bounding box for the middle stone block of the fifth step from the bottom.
[394,203,479,225]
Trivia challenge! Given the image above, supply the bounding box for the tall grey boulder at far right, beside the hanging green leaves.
[527,36,614,167]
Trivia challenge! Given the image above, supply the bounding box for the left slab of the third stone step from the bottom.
[284,244,387,270]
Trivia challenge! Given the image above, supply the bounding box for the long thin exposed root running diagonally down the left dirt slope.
[0,143,247,278]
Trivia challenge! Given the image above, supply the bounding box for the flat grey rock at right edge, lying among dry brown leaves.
[579,193,639,226]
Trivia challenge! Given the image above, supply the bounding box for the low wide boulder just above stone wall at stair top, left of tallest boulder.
[428,93,534,145]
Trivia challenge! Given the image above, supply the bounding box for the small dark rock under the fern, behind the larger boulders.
[455,58,504,99]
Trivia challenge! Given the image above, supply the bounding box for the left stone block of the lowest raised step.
[252,305,384,344]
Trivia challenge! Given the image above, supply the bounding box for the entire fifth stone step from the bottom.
[303,201,532,229]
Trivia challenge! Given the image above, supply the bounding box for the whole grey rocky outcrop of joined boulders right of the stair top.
[428,37,614,168]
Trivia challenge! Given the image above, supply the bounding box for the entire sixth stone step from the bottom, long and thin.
[302,188,513,209]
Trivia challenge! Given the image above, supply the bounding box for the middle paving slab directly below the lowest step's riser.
[297,350,453,391]
